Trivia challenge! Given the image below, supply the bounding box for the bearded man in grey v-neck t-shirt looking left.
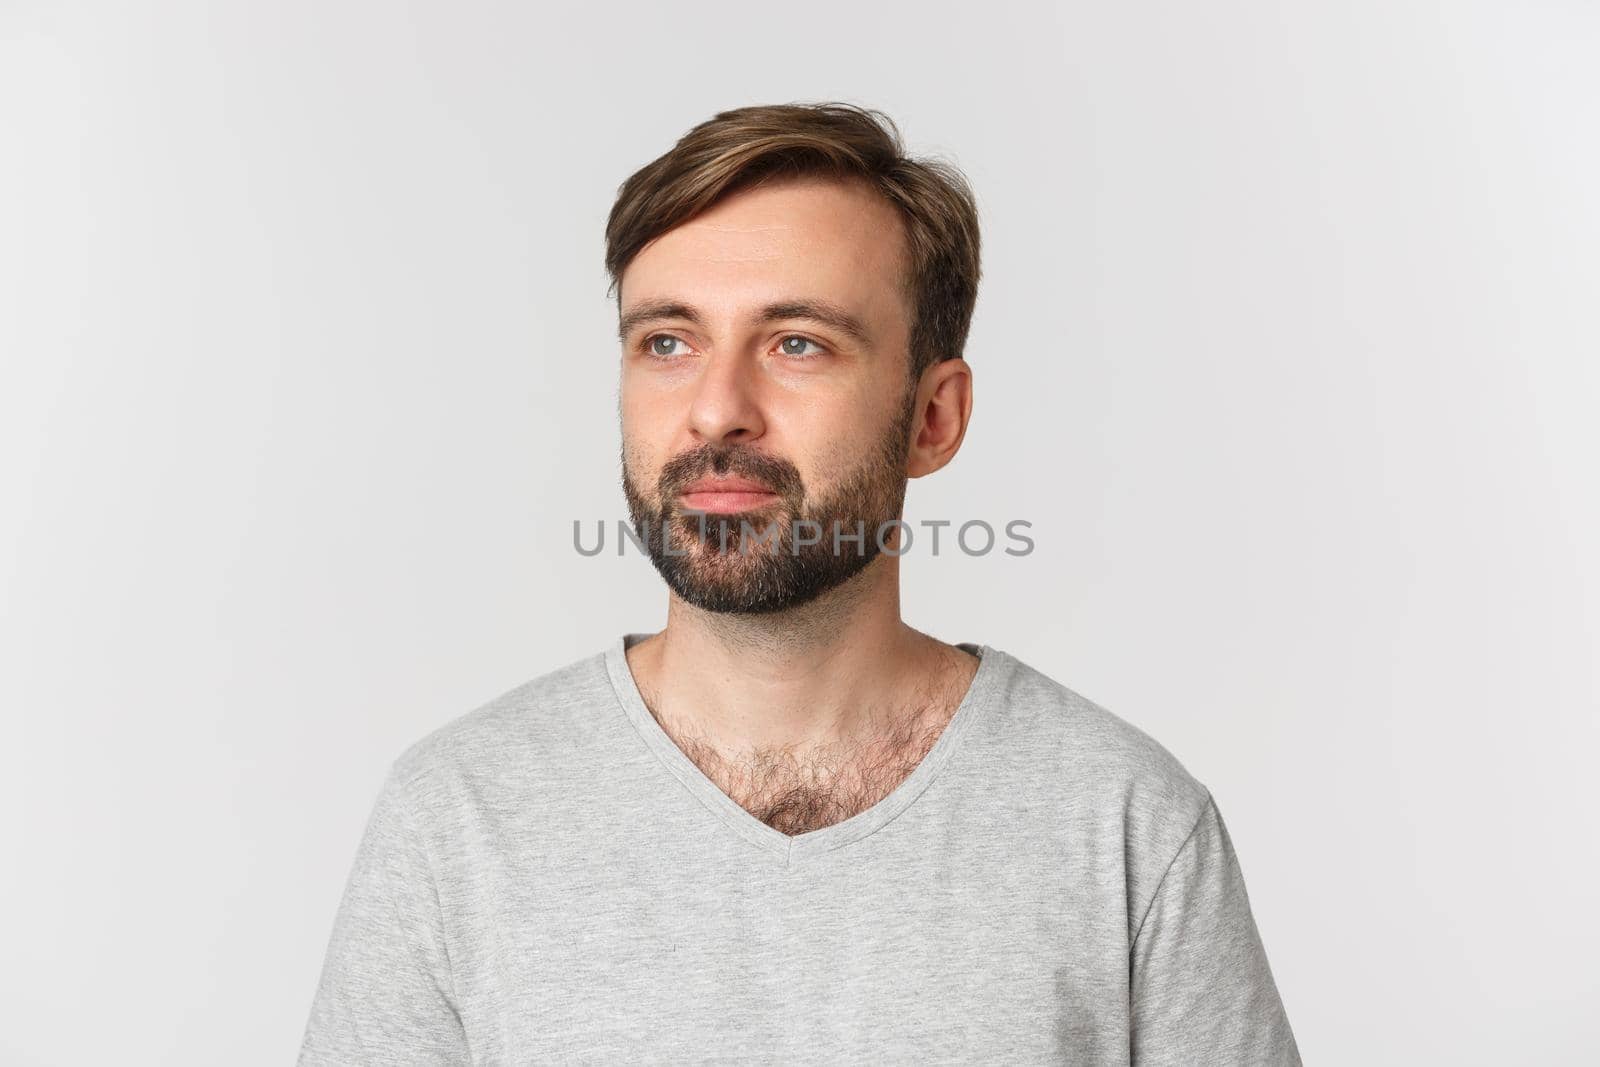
[301,106,1299,1064]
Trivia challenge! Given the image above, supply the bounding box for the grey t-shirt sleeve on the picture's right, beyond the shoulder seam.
[1131,795,1301,1067]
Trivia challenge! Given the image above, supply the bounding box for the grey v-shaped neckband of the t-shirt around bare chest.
[605,633,1011,865]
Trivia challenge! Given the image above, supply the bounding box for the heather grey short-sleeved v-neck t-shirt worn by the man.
[299,633,1301,1064]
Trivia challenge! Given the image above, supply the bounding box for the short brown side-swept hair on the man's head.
[605,104,979,386]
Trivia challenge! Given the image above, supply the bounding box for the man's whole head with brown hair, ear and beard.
[606,104,979,613]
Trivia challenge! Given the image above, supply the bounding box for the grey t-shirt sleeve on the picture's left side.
[298,766,470,1065]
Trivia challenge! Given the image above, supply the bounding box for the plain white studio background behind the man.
[0,0,1600,1064]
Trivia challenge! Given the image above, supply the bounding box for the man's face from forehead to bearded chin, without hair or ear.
[619,178,912,613]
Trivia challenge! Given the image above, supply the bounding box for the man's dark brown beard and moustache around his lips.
[622,397,914,614]
